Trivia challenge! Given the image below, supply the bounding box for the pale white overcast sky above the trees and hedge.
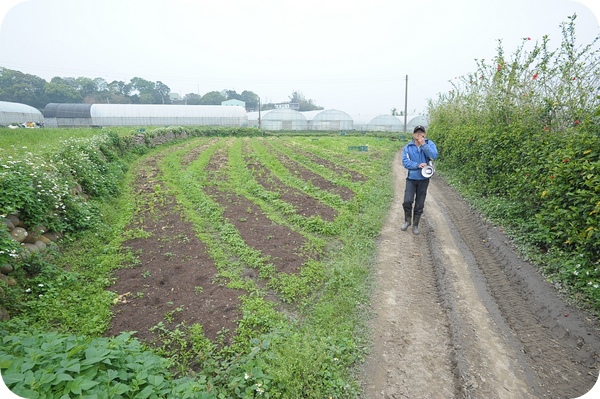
[0,0,600,115]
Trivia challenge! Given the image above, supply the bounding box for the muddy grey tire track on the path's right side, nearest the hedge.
[431,181,600,398]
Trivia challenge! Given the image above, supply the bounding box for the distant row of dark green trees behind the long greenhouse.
[0,67,323,111]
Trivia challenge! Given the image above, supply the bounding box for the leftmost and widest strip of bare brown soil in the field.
[107,154,242,342]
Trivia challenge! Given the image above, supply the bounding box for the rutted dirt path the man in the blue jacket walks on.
[364,154,600,399]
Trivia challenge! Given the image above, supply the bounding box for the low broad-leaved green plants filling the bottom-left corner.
[0,333,215,399]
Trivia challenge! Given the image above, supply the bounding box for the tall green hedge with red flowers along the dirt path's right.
[428,16,600,311]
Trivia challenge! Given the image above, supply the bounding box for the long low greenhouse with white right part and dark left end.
[44,103,248,127]
